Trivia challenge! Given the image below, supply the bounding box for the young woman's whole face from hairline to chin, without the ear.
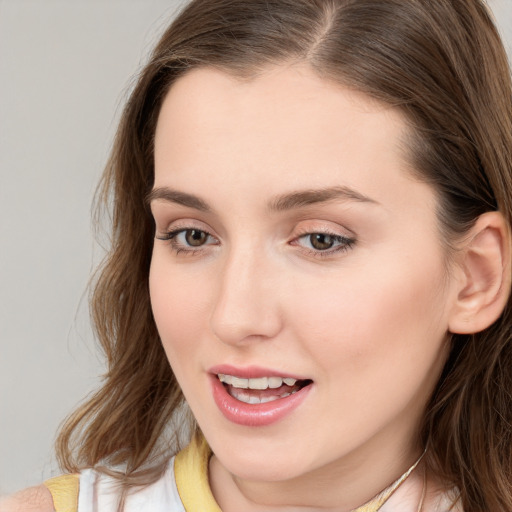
[150,66,454,481]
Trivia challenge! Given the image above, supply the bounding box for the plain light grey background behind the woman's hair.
[0,0,512,494]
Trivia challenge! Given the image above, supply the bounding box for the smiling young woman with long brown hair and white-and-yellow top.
[4,0,512,512]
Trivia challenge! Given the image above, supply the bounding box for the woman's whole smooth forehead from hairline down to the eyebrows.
[155,65,426,212]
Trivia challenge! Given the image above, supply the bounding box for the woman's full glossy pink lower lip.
[212,375,312,427]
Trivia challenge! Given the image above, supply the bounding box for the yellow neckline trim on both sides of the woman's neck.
[174,436,423,512]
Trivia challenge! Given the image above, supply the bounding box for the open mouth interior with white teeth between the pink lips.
[217,373,313,405]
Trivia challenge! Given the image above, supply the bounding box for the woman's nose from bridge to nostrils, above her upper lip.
[211,245,282,345]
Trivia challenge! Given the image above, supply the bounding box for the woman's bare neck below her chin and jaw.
[210,436,423,512]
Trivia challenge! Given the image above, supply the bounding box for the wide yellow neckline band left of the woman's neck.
[174,436,222,512]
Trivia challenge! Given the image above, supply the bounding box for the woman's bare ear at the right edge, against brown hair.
[448,212,511,334]
